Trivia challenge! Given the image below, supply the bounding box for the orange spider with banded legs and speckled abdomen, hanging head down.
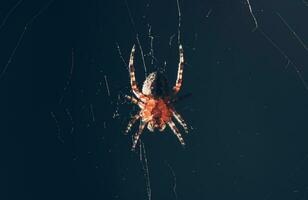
[125,45,188,150]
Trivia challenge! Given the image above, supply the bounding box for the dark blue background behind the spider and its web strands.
[0,0,308,200]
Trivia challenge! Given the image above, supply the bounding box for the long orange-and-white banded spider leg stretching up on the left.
[128,45,145,101]
